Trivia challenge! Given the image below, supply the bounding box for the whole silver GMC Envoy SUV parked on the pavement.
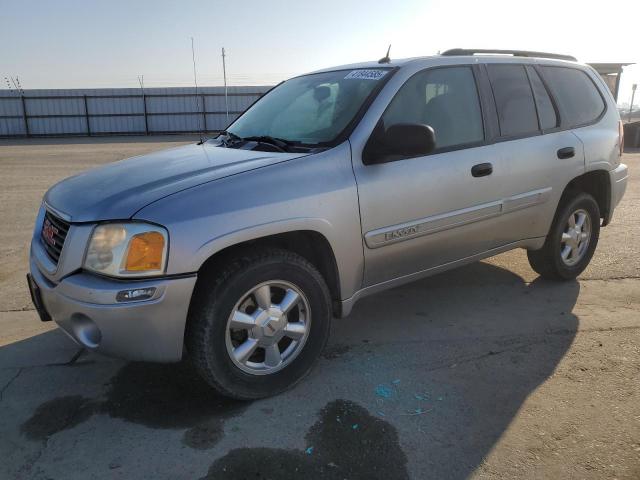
[28,50,627,399]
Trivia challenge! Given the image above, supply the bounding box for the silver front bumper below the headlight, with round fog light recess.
[30,252,197,362]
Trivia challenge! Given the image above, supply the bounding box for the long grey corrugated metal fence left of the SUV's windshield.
[0,86,271,137]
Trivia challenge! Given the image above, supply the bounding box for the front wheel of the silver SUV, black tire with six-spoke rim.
[186,249,332,400]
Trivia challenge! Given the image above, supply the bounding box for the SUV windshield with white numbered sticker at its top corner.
[227,68,389,144]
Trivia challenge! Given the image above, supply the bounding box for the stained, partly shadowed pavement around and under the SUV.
[0,137,640,479]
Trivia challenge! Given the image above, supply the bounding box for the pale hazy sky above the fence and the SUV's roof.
[0,0,640,103]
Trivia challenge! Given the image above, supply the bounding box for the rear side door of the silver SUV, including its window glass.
[486,63,584,245]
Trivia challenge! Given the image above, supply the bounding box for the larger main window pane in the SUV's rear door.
[487,65,538,137]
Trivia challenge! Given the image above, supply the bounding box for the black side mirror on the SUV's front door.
[383,123,436,157]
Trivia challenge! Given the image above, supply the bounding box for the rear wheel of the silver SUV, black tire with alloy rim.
[527,192,600,280]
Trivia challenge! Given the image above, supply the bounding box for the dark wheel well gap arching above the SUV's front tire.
[198,230,342,317]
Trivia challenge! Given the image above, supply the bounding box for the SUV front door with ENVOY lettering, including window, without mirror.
[353,66,506,286]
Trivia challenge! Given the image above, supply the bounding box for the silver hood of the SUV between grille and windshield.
[44,142,305,222]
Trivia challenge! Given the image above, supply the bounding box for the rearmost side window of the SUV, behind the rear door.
[542,67,605,127]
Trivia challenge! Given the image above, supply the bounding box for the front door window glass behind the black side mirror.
[382,67,484,150]
